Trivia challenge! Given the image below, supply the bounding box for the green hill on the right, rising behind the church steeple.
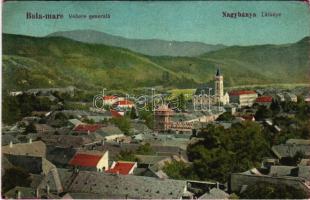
[151,37,310,86]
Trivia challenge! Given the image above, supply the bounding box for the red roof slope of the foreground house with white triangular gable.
[69,153,102,167]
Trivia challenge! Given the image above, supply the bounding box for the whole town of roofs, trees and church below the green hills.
[1,67,310,199]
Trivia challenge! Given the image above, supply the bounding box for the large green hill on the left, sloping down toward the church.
[3,34,194,90]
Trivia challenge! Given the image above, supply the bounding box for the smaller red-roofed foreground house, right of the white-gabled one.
[105,161,137,175]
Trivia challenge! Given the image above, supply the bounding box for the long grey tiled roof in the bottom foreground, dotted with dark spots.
[67,171,186,199]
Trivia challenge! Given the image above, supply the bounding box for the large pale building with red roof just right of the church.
[229,90,258,107]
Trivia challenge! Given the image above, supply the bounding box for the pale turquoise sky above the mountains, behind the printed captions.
[2,1,310,45]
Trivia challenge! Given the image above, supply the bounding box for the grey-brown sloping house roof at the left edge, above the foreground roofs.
[2,141,46,158]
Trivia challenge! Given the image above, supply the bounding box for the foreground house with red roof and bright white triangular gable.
[69,151,109,172]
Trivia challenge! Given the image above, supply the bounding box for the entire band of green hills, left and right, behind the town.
[2,34,310,90]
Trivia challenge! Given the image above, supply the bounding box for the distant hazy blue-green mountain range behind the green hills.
[47,30,225,56]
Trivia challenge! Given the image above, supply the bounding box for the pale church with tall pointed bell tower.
[193,69,229,109]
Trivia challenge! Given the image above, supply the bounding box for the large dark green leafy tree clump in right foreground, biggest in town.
[187,121,270,182]
